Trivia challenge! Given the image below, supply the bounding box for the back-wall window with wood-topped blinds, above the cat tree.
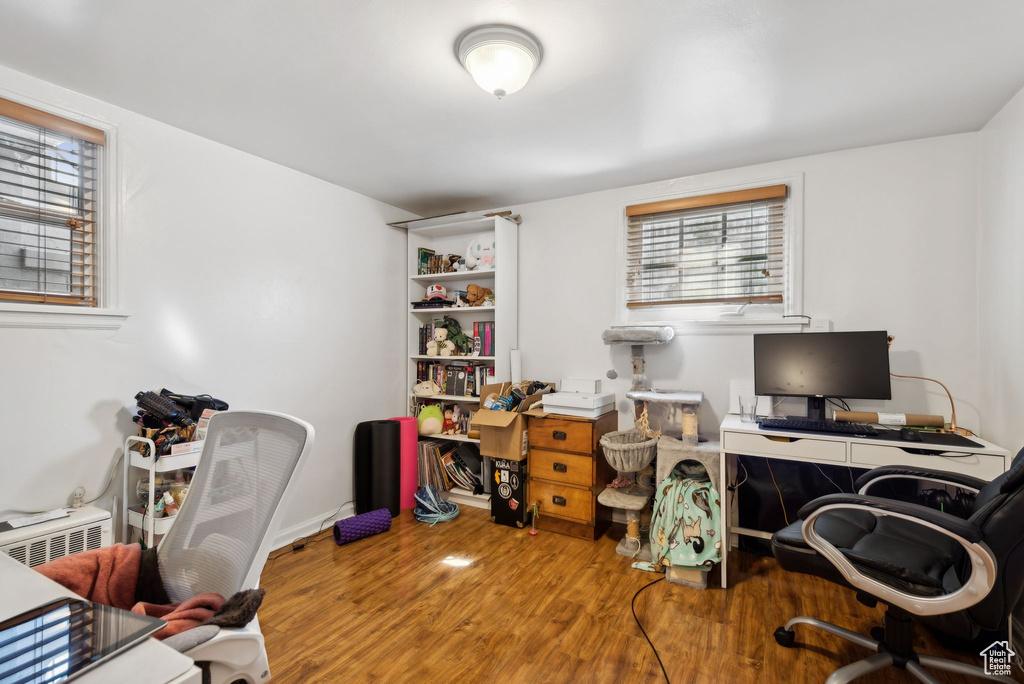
[626,185,787,307]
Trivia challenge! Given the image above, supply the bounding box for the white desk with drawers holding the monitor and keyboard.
[719,415,1013,589]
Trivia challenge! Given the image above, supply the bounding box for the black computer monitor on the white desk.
[754,330,892,420]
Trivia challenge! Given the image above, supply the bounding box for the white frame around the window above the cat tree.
[614,173,810,334]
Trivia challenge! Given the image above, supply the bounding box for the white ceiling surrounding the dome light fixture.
[0,0,1024,215]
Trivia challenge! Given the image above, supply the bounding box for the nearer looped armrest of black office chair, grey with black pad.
[800,494,996,615]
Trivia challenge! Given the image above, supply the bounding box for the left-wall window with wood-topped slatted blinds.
[0,99,104,306]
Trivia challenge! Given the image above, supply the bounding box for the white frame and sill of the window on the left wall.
[0,88,129,330]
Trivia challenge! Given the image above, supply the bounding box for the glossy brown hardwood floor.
[260,507,999,683]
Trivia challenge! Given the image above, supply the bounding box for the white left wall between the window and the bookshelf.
[0,63,408,540]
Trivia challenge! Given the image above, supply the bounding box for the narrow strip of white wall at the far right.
[978,85,1024,452]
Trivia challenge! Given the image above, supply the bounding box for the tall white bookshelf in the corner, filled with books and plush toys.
[402,213,519,508]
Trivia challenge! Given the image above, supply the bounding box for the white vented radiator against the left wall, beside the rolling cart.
[0,506,111,567]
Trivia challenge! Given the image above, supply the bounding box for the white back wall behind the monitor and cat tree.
[515,133,985,434]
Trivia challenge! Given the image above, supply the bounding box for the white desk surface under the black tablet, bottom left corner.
[0,553,203,684]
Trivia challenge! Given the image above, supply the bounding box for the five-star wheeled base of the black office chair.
[775,609,1014,684]
